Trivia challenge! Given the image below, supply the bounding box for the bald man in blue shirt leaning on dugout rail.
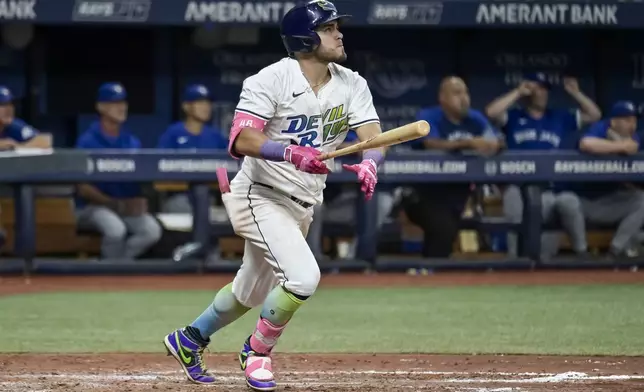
[401,76,503,258]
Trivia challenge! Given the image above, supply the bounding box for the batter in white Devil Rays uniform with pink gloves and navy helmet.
[164,0,384,391]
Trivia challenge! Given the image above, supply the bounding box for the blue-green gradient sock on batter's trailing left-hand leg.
[190,283,250,340]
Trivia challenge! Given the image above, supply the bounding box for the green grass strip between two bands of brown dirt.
[0,285,644,355]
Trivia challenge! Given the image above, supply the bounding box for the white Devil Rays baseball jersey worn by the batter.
[235,58,380,204]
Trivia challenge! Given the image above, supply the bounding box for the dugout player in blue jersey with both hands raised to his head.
[485,72,601,261]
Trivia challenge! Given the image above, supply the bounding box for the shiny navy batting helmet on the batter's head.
[280,0,351,57]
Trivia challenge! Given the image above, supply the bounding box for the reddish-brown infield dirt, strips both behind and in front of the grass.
[0,271,644,392]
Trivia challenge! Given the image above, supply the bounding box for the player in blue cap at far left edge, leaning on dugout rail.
[0,86,52,150]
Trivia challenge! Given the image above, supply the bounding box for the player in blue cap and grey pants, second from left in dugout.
[76,83,162,259]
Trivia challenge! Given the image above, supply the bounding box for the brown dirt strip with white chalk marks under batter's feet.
[0,354,644,392]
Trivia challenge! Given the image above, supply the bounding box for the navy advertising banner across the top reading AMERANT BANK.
[6,0,644,28]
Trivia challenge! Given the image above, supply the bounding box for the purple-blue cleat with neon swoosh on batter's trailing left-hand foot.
[163,329,215,384]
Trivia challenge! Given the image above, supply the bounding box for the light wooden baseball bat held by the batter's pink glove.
[320,120,429,160]
